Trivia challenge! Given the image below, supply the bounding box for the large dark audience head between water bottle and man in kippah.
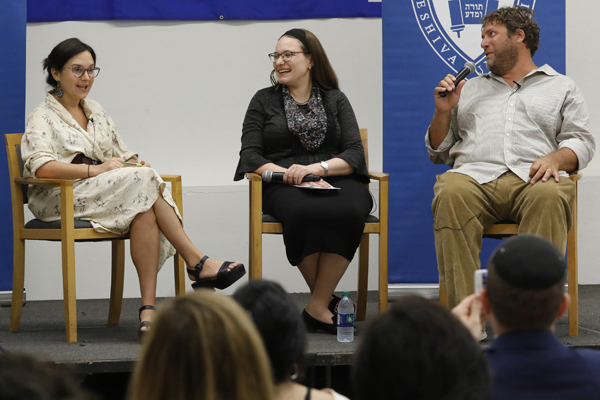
[353,296,490,400]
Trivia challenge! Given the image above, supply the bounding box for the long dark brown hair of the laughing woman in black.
[271,28,339,90]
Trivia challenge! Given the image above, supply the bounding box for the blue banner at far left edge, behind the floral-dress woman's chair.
[0,0,27,291]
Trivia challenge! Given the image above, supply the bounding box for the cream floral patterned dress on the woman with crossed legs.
[21,93,181,267]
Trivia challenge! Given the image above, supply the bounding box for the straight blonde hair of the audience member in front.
[129,290,274,400]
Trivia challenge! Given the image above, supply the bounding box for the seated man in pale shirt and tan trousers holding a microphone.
[425,6,595,307]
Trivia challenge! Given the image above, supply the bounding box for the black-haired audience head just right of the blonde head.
[233,280,306,384]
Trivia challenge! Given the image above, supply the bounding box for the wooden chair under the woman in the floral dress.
[4,133,185,342]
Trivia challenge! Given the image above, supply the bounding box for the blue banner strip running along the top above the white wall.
[27,0,381,22]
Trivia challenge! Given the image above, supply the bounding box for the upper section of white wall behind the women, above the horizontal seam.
[26,19,382,186]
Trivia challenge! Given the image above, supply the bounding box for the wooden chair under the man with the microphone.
[440,172,581,336]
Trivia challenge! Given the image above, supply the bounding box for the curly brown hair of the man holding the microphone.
[481,6,540,57]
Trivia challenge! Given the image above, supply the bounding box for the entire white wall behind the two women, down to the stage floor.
[25,19,382,300]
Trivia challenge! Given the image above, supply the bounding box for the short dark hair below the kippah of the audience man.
[486,263,565,330]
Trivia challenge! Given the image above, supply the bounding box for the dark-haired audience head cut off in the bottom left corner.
[0,353,96,400]
